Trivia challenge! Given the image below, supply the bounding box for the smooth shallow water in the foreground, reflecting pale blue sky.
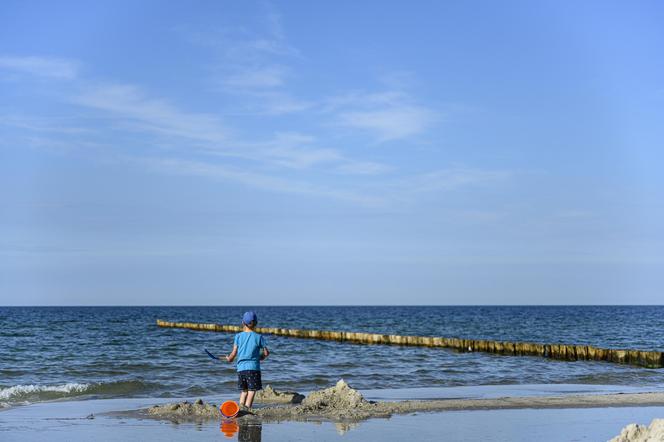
[0,387,664,442]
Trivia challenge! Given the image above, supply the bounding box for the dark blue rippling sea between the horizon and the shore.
[0,306,664,406]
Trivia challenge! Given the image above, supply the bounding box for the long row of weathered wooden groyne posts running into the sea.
[157,319,664,368]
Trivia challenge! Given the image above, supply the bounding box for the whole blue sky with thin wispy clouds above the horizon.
[0,1,664,305]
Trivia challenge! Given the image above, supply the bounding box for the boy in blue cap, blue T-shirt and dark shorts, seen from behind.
[226,312,270,408]
